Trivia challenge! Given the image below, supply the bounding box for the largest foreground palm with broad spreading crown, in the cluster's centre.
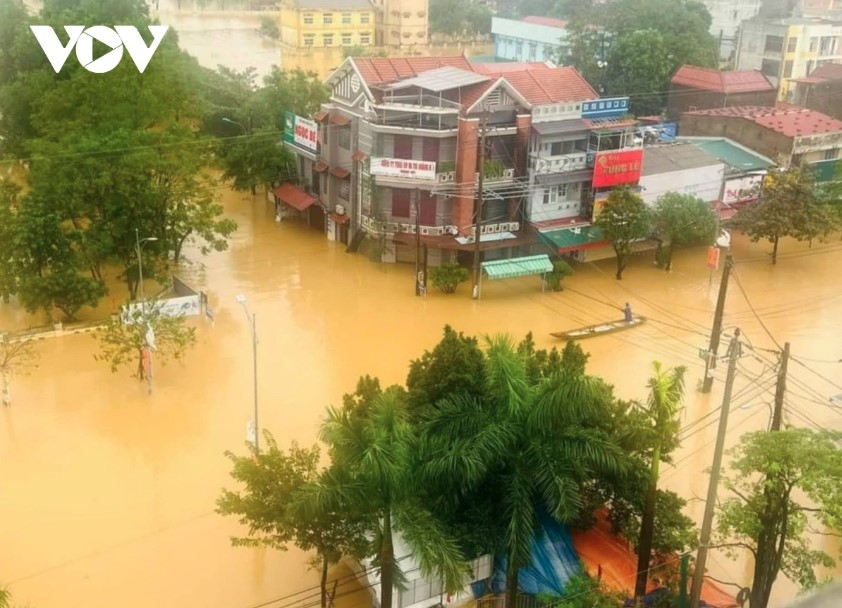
[421,336,624,608]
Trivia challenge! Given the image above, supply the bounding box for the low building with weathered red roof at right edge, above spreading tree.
[679,106,842,168]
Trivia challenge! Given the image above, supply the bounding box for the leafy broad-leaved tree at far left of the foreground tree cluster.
[216,431,369,608]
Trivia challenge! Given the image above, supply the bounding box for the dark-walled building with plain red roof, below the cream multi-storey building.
[667,65,777,119]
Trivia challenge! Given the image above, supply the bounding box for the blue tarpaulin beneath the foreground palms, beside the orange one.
[471,516,582,598]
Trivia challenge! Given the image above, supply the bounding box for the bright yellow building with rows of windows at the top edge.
[280,0,375,50]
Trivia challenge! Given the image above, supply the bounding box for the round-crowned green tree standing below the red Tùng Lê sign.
[594,188,652,281]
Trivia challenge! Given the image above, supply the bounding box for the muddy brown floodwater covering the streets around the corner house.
[0,186,842,608]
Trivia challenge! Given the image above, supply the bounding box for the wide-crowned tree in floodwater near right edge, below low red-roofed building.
[733,167,838,264]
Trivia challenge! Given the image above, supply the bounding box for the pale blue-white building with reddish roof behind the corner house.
[491,17,569,63]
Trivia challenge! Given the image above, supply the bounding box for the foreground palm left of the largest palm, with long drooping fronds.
[298,388,468,608]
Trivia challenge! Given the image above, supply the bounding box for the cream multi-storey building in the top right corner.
[736,17,842,102]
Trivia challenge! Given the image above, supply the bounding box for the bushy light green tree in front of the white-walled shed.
[652,192,719,270]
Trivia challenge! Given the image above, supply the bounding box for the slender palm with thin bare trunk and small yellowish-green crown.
[634,361,687,601]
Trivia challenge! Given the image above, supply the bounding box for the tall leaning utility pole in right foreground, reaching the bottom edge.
[690,329,740,608]
